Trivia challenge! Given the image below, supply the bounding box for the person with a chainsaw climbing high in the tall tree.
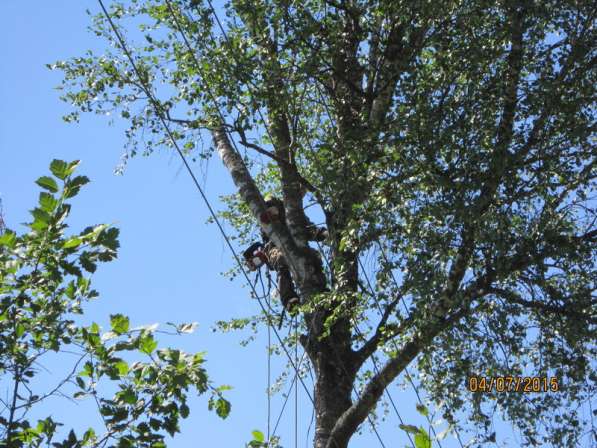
[243,198,328,325]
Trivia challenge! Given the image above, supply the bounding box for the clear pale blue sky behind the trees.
[0,0,517,448]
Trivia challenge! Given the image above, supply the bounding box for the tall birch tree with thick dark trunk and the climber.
[52,0,597,448]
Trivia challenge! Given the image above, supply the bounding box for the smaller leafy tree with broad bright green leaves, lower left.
[0,160,230,448]
